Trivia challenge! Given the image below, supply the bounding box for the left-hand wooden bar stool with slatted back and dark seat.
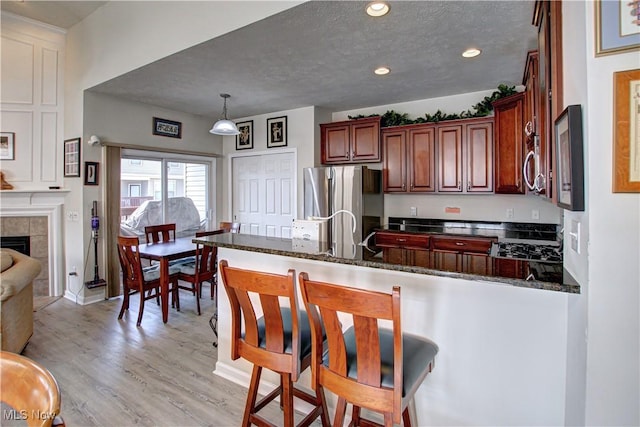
[220,260,329,427]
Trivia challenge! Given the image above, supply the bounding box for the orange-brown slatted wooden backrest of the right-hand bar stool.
[300,273,403,423]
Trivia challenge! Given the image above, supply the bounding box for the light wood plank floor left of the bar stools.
[23,288,318,427]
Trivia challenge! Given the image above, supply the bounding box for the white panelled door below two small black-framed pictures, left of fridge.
[231,153,296,238]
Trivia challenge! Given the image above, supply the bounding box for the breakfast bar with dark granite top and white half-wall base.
[194,233,579,425]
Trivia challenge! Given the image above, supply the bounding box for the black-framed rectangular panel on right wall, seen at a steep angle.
[555,105,584,211]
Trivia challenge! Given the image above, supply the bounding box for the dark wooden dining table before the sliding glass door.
[138,236,196,323]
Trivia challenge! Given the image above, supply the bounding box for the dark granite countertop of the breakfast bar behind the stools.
[193,233,580,294]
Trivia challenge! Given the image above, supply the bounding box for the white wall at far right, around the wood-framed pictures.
[584,2,640,426]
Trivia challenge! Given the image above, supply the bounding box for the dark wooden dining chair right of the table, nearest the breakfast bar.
[178,230,224,315]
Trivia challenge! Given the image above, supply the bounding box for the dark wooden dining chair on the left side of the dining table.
[118,236,180,326]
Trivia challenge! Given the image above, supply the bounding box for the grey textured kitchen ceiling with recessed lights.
[2,1,537,119]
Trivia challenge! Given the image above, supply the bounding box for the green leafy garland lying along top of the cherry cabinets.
[348,85,517,128]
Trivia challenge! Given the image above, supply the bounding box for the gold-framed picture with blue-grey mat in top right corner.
[595,0,640,56]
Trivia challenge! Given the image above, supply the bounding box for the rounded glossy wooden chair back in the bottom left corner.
[0,351,65,427]
